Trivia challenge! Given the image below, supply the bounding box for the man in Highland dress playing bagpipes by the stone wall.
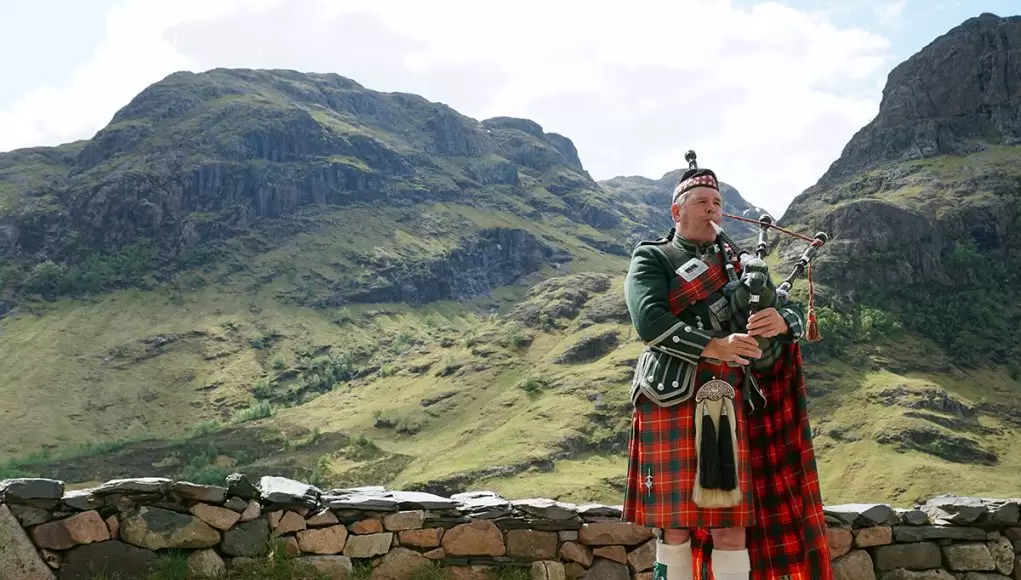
[623,151,832,580]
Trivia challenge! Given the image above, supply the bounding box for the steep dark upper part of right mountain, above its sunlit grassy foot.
[780,14,1021,361]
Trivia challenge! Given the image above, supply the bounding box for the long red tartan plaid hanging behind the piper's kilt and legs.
[691,344,833,580]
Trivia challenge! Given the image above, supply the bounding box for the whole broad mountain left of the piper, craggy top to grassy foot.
[0,65,726,504]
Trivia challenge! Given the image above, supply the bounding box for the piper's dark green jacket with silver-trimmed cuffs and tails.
[624,230,805,405]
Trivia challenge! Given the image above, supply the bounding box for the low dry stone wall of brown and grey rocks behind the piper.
[0,474,1021,580]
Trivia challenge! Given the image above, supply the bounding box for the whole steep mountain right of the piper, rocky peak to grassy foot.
[777,14,1021,502]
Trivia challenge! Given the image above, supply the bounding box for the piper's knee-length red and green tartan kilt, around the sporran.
[622,360,756,529]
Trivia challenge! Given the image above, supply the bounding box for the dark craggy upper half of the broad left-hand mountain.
[0,69,661,302]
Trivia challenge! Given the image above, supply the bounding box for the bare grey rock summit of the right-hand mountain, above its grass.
[820,13,1021,185]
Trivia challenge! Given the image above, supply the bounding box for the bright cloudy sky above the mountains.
[0,0,1021,215]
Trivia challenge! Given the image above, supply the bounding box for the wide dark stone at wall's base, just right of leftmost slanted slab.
[60,540,159,580]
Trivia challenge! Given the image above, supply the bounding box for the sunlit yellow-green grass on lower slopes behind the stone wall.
[7,245,1021,504]
